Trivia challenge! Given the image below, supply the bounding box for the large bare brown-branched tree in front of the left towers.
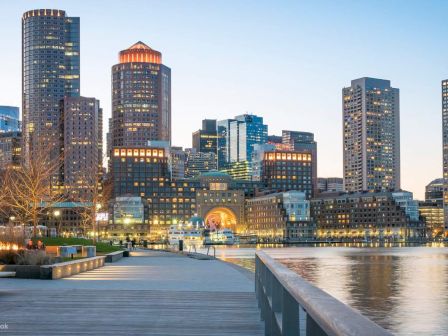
[3,148,64,237]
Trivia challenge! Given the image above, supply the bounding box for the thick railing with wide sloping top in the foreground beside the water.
[255,251,392,336]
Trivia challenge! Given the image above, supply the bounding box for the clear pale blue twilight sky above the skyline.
[0,0,448,198]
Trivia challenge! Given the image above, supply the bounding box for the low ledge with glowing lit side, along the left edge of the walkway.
[40,256,106,280]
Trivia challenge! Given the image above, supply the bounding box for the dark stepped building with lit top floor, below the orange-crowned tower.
[109,145,199,240]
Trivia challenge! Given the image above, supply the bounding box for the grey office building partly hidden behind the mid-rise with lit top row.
[282,131,318,196]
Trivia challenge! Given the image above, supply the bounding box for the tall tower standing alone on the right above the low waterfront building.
[342,77,400,192]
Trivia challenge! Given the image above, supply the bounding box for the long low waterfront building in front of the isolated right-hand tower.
[311,192,426,241]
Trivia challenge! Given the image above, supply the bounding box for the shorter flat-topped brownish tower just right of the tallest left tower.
[61,97,103,202]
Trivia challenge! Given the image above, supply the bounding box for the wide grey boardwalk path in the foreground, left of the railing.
[0,252,264,336]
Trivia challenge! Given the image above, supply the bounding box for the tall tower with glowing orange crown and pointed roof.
[111,42,171,147]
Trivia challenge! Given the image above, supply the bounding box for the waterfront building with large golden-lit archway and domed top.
[196,171,246,233]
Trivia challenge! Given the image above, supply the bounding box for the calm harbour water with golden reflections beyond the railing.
[202,247,448,335]
